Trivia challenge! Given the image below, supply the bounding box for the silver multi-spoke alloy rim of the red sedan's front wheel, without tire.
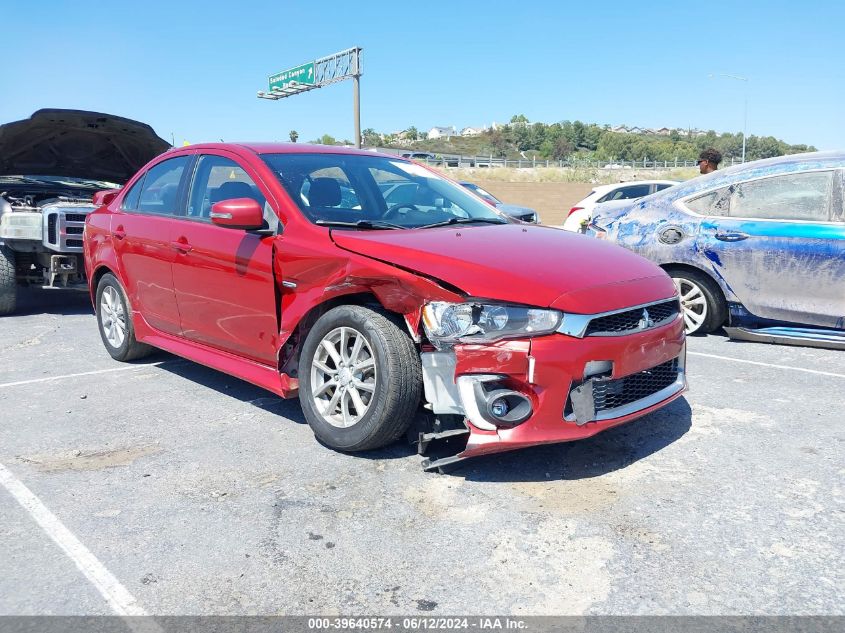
[311,327,377,428]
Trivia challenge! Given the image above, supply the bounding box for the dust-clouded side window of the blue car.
[730,170,834,222]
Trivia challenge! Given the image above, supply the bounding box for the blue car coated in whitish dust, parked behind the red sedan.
[588,152,845,349]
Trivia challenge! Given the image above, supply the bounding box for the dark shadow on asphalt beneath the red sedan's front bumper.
[450,398,692,482]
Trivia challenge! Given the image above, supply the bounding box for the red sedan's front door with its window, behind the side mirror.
[173,151,279,365]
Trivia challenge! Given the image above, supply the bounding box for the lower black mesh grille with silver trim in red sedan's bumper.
[563,357,684,426]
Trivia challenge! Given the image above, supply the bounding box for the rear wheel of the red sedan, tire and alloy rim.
[95,273,153,362]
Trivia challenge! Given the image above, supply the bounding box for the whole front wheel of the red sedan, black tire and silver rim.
[299,305,422,452]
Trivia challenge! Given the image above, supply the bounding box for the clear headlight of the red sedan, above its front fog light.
[423,301,563,348]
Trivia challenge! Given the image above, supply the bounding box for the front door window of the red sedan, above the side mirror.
[188,154,268,221]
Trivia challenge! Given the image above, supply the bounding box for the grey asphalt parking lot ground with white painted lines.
[0,292,845,615]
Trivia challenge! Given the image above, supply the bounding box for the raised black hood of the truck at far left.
[0,109,170,183]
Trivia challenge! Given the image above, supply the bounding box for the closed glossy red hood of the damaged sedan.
[332,224,675,313]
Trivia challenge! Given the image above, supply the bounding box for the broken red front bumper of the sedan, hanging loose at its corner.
[423,317,687,468]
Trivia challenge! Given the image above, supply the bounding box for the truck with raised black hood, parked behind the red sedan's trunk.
[0,109,170,315]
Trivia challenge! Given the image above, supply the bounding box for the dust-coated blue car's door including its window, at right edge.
[687,170,845,328]
